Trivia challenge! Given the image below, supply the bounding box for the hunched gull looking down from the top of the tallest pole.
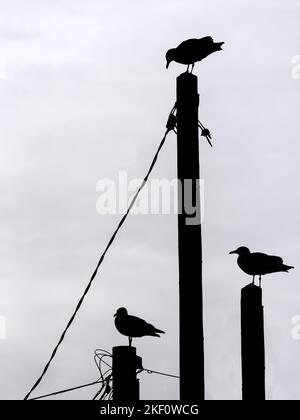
[166,36,224,73]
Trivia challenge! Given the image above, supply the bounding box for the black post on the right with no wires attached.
[241,284,265,401]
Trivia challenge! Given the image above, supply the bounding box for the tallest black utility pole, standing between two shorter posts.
[177,72,204,401]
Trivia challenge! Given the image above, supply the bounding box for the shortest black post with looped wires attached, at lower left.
[112,346,140,403]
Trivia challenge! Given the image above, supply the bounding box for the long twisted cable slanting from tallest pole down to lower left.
[24,115,170,400]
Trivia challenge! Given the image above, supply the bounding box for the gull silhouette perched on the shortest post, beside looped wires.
[114,308,165,346]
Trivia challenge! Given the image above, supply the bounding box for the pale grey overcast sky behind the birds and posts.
[0,0,300,399]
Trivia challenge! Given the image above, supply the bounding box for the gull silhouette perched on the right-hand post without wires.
[229,246,294,286]
